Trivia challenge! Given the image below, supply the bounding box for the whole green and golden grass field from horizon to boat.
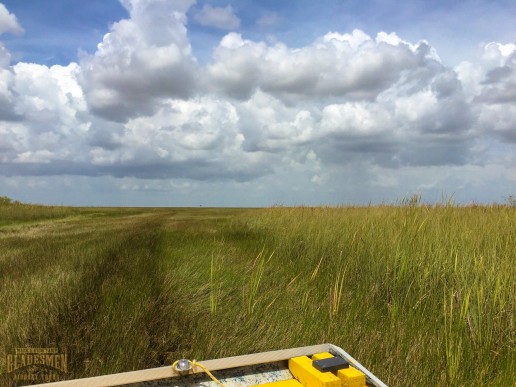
[0,202,516,386]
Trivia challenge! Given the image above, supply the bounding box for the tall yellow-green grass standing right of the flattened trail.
[227,203,516,385]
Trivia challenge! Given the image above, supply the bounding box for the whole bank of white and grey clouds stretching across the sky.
[0,0,516,206]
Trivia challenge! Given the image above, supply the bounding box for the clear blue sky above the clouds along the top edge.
[3,0,516,65]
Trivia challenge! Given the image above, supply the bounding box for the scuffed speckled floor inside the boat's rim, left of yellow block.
[125,361,292,387]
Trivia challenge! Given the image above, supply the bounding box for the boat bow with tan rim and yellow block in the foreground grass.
[35,344,386,387]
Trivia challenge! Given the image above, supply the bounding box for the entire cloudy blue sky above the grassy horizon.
[0,0,516,207]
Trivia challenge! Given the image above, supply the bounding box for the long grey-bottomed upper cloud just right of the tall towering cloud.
[207,30,443,103]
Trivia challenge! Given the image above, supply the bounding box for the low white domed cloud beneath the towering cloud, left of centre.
[81,98,270,180]
